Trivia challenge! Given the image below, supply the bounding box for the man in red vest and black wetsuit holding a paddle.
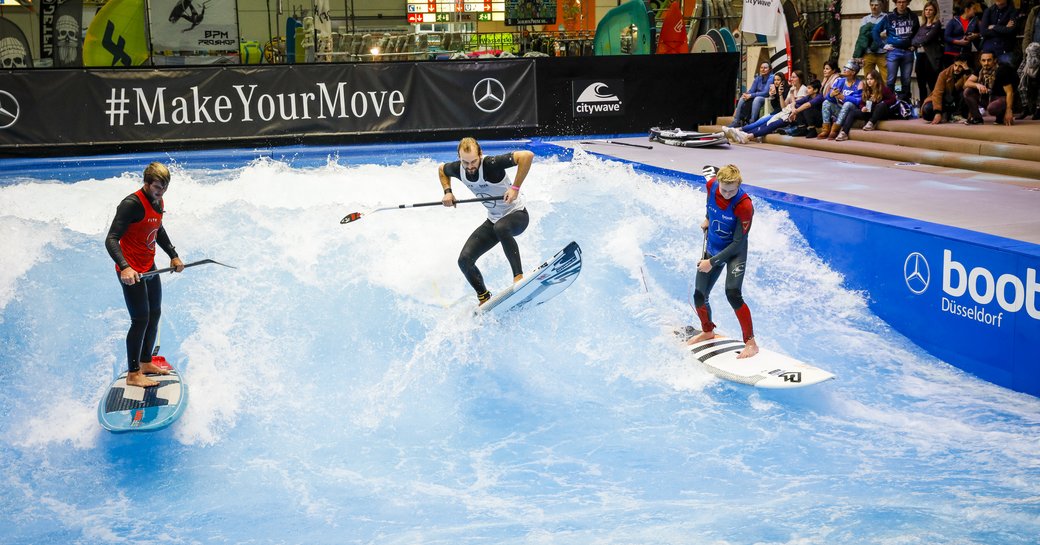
[105,162,184,388]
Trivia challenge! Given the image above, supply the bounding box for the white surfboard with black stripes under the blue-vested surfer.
[675,326,834,388]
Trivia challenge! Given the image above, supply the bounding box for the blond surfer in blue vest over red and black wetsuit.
[688,164,758,359]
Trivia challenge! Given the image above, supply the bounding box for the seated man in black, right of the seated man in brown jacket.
[964,51,1018,127]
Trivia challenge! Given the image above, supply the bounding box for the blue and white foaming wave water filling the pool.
[0,142,1040,545]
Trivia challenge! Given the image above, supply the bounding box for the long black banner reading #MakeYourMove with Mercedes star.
[0,59,538,148]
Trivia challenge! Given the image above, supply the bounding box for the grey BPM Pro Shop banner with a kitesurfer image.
[148,0,238,52]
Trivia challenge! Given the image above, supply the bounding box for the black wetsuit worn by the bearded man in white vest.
[444,153,530,294]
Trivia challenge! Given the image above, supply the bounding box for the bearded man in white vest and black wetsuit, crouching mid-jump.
[438,137,535,305]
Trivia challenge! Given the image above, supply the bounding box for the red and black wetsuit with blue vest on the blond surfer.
[694,178,755,342]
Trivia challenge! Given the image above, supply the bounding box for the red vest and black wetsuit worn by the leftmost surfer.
[105,189,177,372]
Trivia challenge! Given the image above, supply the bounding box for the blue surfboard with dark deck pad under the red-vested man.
[98,356,188,434]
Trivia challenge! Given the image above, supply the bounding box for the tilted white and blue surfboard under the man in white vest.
[476,242,581,314]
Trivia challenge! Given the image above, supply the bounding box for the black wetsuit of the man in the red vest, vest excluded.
[105,193,177,372]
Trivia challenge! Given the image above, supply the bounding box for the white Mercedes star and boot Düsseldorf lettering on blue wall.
[903,250,1040,328]
